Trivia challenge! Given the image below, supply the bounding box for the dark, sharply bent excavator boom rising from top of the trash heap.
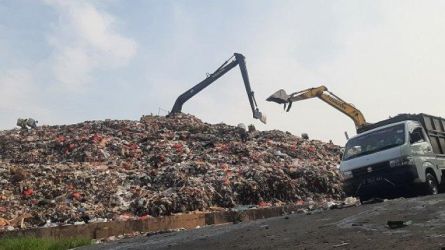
[169,53,266,123]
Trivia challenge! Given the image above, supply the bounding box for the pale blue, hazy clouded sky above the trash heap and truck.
[0,0,445,145]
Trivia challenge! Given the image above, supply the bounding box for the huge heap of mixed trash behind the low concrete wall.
[0,114,344,230]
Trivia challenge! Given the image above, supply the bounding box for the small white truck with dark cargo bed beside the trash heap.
[340,114,445,200]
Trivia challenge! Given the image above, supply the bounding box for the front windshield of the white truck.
[343,124,405,160]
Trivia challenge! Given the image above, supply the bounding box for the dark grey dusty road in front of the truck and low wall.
[84,194,445,249]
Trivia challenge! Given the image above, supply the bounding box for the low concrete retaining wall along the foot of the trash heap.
[0,205,303,239]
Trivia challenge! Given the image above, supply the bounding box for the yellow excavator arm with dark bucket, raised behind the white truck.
[266,86,368,130]
